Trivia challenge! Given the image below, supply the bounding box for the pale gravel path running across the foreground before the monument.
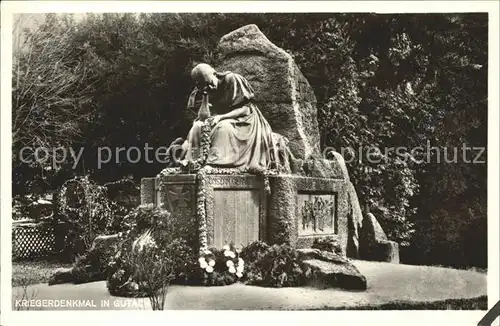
[12,261,487,310]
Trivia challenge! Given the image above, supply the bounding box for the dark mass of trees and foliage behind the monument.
[13,13,488,267]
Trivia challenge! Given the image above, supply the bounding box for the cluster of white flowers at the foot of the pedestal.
[198,245,245,286]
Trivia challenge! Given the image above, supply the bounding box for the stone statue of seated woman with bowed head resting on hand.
[166,64,292,170]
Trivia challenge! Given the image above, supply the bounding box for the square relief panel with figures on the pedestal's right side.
[296,193,337,236]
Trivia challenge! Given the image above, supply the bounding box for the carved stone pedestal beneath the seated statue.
[141,174,349,255]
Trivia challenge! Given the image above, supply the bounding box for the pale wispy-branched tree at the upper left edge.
[12,15,93,165]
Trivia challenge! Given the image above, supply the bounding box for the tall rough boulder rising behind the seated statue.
[217,25,320,159]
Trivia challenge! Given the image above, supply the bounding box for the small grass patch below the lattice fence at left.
[12,260,72,286]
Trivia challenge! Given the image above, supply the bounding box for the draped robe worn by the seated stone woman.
[186,72,286,169]
